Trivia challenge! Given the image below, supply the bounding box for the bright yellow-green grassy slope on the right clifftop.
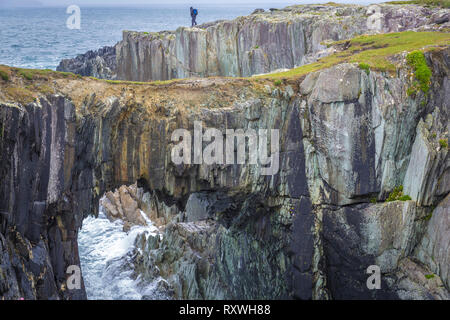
[254,31,450,78]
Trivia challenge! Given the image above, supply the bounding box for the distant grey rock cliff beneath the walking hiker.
[58,3,450,81]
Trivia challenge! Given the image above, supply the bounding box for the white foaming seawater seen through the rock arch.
[78,208,160,300]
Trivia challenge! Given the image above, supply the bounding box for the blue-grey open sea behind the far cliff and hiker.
[0,1,384,70]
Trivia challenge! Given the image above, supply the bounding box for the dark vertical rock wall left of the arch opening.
[0,96,92,299]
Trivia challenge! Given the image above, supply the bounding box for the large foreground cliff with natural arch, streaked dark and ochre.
[0,35,450,299]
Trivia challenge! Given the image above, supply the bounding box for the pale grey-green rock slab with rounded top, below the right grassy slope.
[302,64,378,204]
